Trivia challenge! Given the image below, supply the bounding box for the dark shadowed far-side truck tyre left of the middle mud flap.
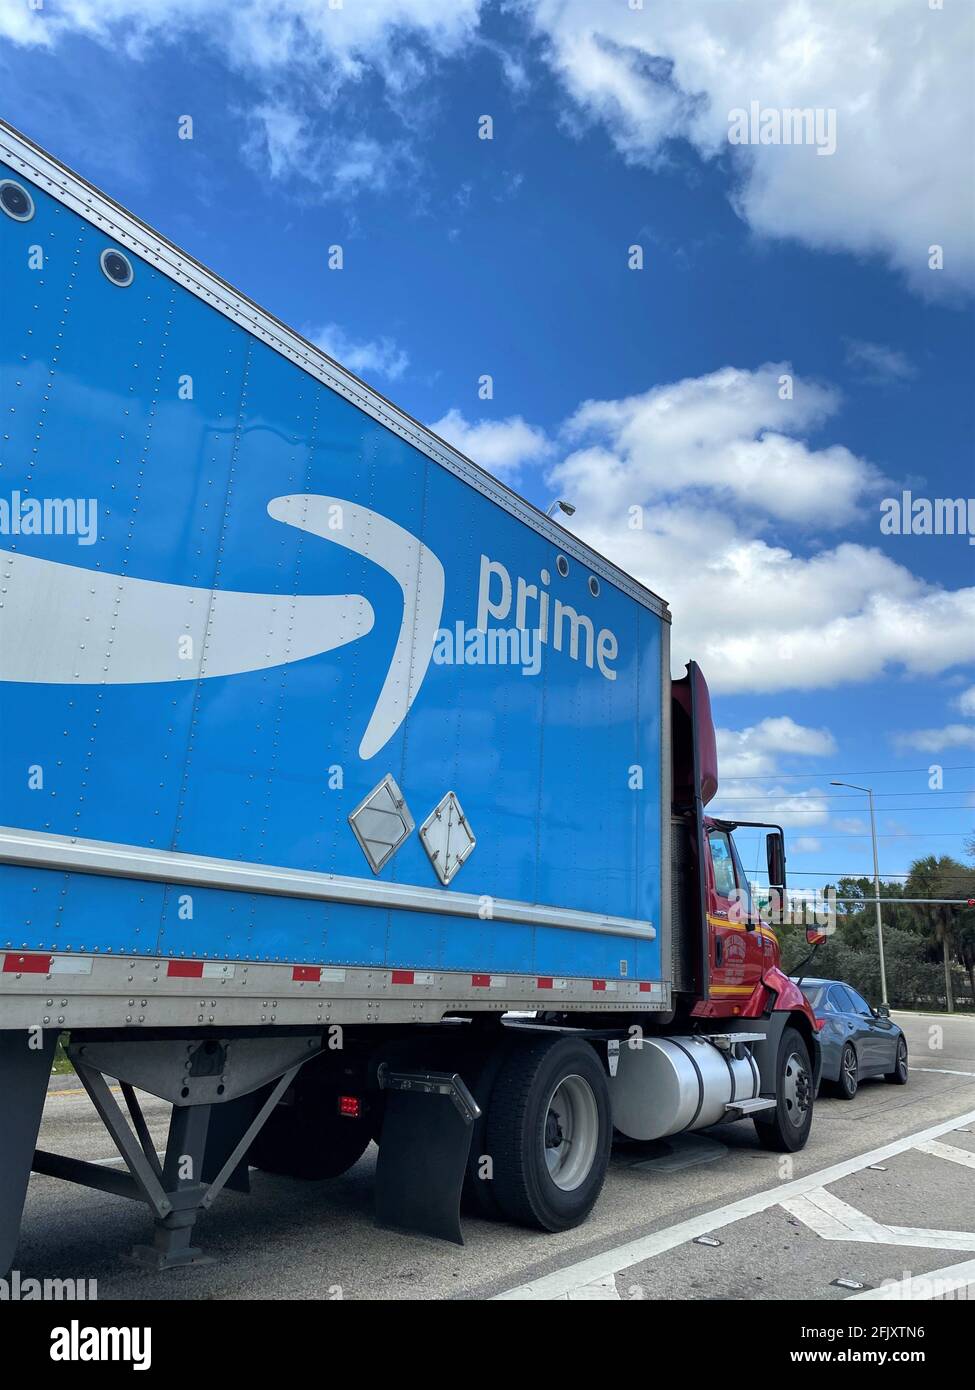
[248,1091,373,1180]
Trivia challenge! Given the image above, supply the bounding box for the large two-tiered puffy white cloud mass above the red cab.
[547,364,975,692]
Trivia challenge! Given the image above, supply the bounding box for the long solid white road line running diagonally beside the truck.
[495,1111,975,1300]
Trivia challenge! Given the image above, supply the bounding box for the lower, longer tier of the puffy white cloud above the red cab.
[569,493,975,692]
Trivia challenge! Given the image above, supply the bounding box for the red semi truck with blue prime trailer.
[0,125,819,1269]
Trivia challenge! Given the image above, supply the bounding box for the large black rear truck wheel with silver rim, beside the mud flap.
[487,1038,612,1230]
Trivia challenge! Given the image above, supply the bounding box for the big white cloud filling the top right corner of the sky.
[520,0,975,295]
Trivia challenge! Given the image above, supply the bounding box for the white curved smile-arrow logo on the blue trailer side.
[0,493,444,759]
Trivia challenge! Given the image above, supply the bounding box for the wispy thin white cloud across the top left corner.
[0,0,481,197]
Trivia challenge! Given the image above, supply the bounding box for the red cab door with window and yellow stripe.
[708,828,764,1004]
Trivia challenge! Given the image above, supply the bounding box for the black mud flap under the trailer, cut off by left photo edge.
[0,1029,57,1276]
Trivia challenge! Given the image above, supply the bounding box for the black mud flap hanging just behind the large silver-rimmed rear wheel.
[376,1063,481,1245]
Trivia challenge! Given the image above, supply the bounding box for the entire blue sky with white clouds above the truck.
[0,0,975,884]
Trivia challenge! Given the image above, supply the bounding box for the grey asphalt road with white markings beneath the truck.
[15,1015,975,1300]
